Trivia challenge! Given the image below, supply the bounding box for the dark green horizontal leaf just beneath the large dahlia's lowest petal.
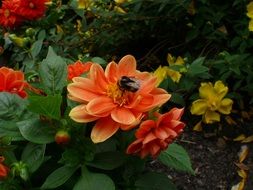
[87,152,126,170]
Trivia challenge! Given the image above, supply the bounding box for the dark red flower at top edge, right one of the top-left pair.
[17,0,47,20]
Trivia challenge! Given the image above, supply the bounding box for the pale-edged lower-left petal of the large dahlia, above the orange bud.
[69,105,98,123]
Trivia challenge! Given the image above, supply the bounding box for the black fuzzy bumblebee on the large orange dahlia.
[118,76,140,92]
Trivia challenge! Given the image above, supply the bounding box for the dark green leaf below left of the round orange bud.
[21,143,46,173]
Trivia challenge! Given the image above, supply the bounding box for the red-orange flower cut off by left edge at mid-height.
[0,67,28,98]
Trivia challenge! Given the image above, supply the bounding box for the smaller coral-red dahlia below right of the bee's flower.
[127,108,185,158]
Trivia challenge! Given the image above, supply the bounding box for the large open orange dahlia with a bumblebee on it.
[68,55,171,143]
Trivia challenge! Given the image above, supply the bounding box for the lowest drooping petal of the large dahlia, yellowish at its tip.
[91,117,119,143]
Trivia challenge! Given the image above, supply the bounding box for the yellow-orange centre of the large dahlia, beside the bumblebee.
[106,84,128,106]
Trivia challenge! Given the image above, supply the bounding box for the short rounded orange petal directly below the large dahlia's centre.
[111,107,137,125]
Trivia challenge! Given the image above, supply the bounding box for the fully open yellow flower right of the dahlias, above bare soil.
[190,81,233,123]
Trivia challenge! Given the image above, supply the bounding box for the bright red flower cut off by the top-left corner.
[0,0,23,28]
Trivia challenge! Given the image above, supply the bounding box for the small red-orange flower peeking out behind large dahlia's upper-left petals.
[68,61,93,80]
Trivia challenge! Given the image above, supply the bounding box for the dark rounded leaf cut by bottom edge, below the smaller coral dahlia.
[135,172,177,190]
